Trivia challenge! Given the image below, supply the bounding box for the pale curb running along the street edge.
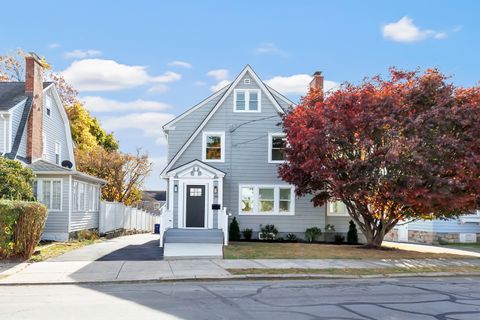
[0,272,480,287]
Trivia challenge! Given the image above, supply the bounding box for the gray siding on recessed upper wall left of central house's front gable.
[168,89,226,161]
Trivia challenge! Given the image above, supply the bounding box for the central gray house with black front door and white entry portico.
[160,65,349,257]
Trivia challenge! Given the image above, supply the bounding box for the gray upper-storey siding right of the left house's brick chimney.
[43,89,72,163]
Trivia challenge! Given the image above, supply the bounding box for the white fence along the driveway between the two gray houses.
[98,201,160,234]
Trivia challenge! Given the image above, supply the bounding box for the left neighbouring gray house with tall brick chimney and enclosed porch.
[0,54,104,241]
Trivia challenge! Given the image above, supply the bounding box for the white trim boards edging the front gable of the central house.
[161,64,285,175]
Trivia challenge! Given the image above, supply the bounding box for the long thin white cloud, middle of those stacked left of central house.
[82,96,171,112]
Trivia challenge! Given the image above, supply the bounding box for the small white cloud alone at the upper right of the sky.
[382,16,448,42]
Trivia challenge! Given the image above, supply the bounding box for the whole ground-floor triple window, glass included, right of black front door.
[239,185,295,215]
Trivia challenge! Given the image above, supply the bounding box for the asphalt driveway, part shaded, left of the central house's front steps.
[48,234,163,262]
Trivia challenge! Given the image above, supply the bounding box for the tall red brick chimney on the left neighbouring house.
[25,52,43,163]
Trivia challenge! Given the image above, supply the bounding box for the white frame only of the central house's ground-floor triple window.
[238,184,295,216]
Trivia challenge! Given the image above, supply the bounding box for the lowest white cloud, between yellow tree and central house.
[102,112,175,145]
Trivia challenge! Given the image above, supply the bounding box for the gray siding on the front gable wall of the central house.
[169,74,325,233]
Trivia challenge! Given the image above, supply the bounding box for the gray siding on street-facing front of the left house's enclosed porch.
[37,174,70,240]
